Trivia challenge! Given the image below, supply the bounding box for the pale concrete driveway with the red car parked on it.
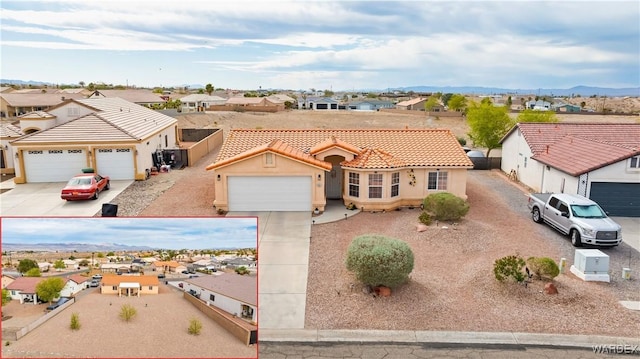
[0,180,133,217]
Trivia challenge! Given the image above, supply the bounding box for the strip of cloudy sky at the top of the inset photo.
[1,217,258,250]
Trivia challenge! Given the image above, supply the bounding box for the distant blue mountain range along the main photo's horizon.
[0,79,640,97]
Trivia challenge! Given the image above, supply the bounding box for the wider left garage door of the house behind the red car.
[22,150,87,182]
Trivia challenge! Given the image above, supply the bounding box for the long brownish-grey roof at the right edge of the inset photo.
[185,273,258,305]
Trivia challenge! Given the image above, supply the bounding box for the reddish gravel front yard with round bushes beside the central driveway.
[305,171,640,337]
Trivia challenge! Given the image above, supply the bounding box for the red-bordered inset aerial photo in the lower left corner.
[0,217,258,358]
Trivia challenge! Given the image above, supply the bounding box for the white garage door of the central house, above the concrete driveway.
[228,176,312,211]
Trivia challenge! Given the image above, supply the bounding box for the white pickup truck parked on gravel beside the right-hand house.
[528,193,622,247]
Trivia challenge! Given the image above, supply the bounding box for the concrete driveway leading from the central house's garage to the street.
[227,212,311,330]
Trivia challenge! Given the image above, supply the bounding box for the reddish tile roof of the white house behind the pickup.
[505,123,640,176]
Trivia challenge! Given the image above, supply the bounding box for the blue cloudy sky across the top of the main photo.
[0,0,640,91]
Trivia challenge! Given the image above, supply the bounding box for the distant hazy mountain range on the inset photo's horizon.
[2,243,155,252]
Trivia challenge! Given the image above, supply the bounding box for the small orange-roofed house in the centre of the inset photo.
[100,274,160,297]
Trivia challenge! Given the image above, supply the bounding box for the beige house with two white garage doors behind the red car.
[10,97,178,183]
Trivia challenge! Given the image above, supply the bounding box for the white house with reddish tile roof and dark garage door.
[501,123,640,217]
